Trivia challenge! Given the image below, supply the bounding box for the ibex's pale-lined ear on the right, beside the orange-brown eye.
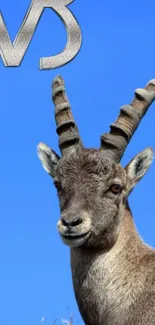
[125,148,154,195]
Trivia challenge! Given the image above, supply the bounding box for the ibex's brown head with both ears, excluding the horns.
[39,144,153,248]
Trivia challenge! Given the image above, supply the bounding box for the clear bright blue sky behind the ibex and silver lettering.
[0,0,155,325]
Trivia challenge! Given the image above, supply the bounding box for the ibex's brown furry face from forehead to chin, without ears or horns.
[55,150,126,247]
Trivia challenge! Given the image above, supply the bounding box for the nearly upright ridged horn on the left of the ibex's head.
[52,76,82,155]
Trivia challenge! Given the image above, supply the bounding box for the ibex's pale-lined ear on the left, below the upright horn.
[37,142,60,178]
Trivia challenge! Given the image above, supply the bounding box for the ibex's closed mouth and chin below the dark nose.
[60,231,90,247]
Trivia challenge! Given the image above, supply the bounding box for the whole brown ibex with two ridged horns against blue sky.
[38,77,155,325]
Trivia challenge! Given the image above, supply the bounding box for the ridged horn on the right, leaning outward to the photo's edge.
[101,79,155,162]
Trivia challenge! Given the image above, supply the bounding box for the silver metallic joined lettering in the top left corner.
[0,0,82,70]
